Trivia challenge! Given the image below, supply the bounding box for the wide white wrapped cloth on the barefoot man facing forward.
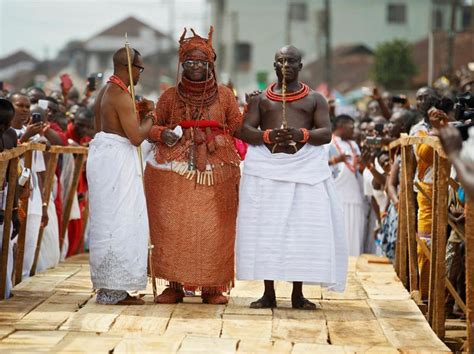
[236,144,348,291]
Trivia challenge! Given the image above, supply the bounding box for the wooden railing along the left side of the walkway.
[0,143,88,299]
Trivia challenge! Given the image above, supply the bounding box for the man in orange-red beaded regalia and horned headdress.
[145,27,242,305]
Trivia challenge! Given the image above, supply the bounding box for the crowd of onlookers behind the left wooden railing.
[0,81,94,297]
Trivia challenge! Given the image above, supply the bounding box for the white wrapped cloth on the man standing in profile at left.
[87,132,149,291]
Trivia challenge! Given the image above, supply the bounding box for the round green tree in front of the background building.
[371,39,417,89]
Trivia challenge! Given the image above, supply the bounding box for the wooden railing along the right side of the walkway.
[389,135,474,353]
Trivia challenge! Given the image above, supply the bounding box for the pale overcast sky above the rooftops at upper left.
[0,0,207,59]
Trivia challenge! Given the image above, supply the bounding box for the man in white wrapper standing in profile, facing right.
[87,48,154,305]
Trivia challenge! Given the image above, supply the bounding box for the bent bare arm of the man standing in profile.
[115,92,153,146]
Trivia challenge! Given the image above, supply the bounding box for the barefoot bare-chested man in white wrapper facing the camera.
[236,46,348,310]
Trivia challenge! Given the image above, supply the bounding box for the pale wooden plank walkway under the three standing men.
[0,255,450,354]
